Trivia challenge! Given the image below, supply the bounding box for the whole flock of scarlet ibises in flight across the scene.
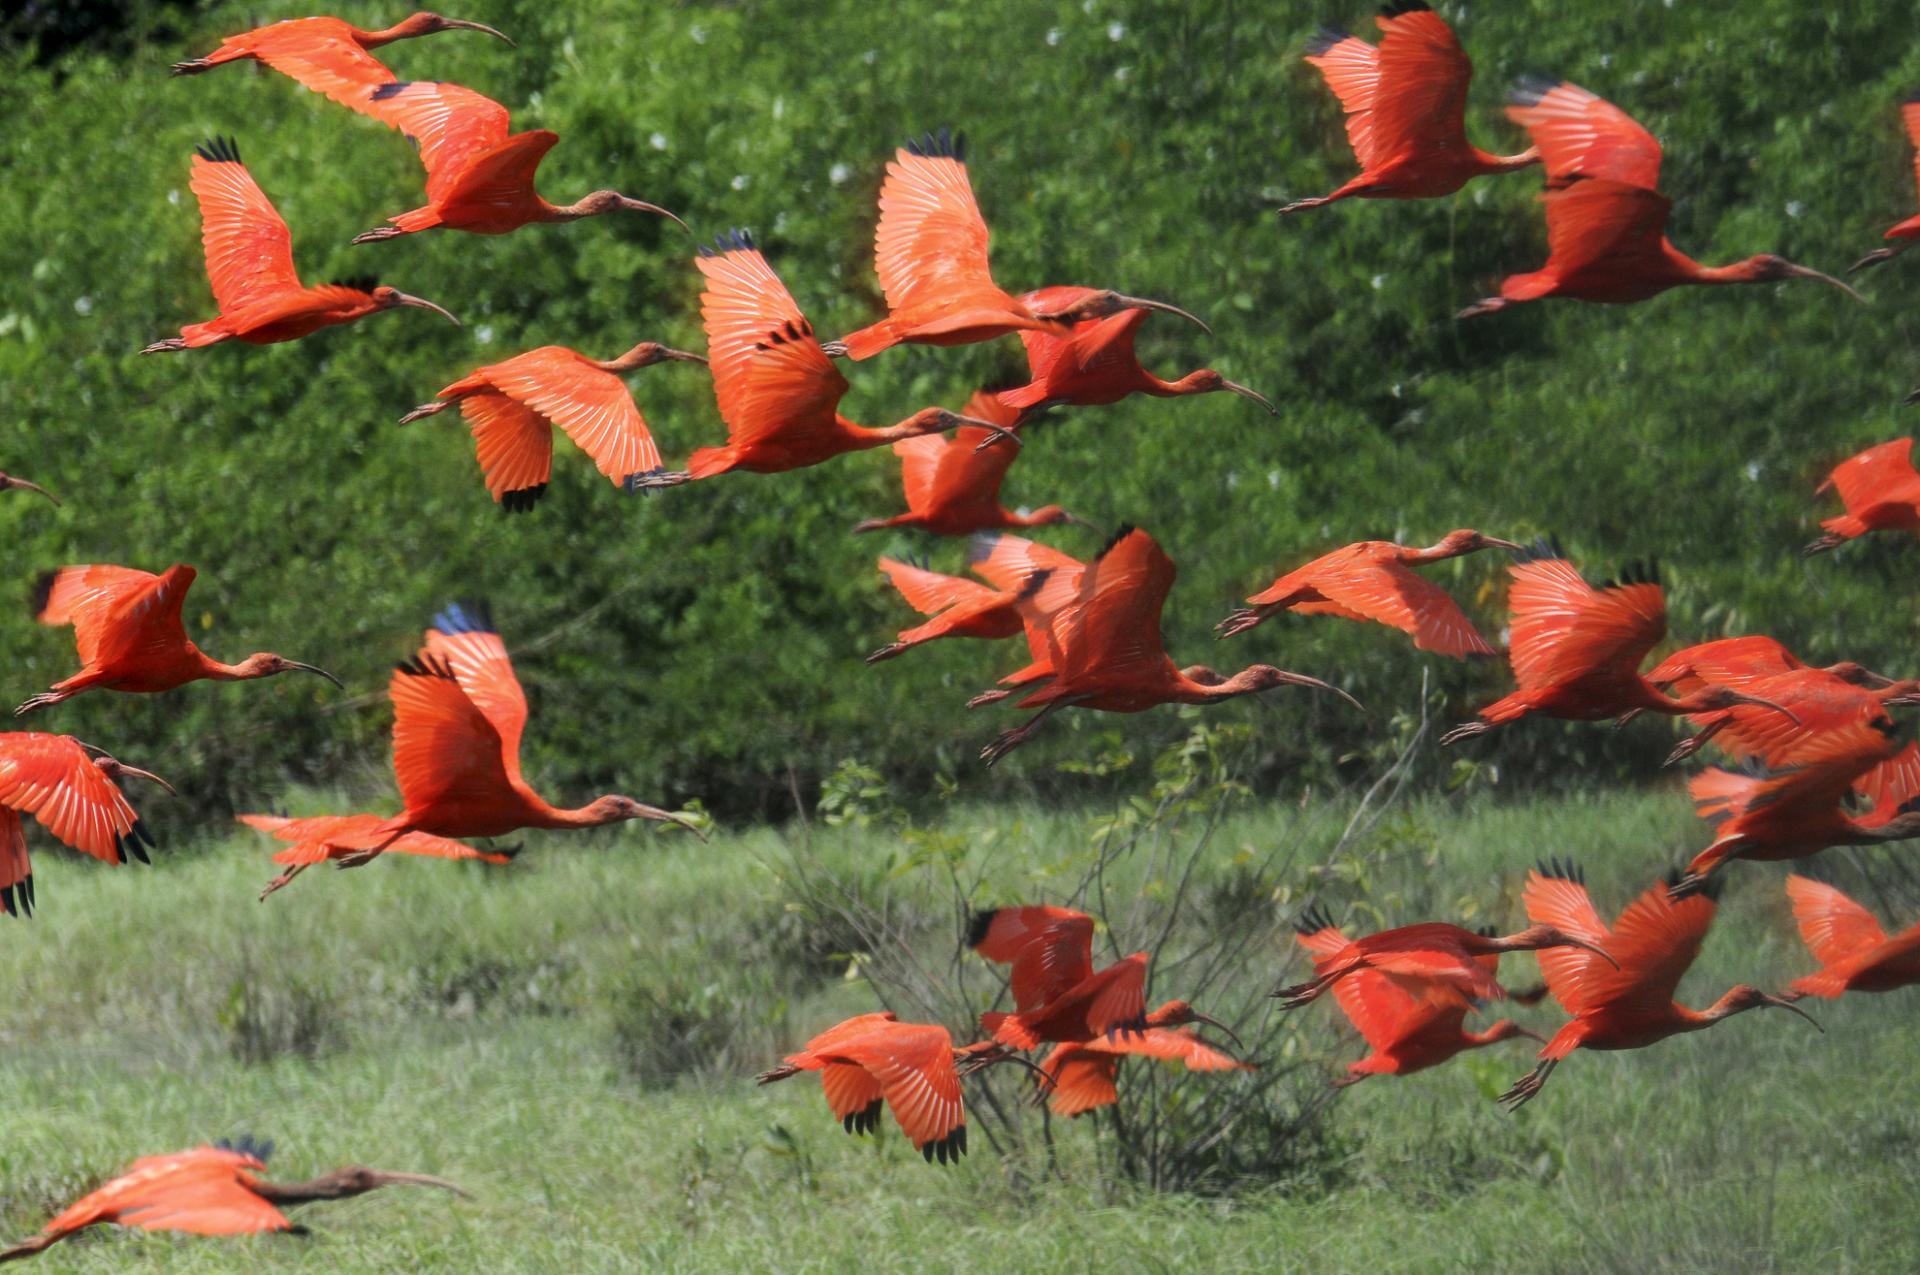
[0,0,1920,1262]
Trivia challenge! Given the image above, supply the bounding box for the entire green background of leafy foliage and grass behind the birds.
[0,0,1920,1271]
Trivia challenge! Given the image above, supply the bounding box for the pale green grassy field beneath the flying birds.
[0,791,1920,1271]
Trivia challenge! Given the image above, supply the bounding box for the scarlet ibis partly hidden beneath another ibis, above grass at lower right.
[1294,908,1546,1089]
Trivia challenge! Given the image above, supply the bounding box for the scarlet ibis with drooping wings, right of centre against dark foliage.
[1215,528,1523,659]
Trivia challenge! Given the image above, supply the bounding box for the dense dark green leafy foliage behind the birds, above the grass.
[11,0,1920,810]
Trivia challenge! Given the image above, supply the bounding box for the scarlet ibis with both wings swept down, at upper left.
[399,342,707,513]
